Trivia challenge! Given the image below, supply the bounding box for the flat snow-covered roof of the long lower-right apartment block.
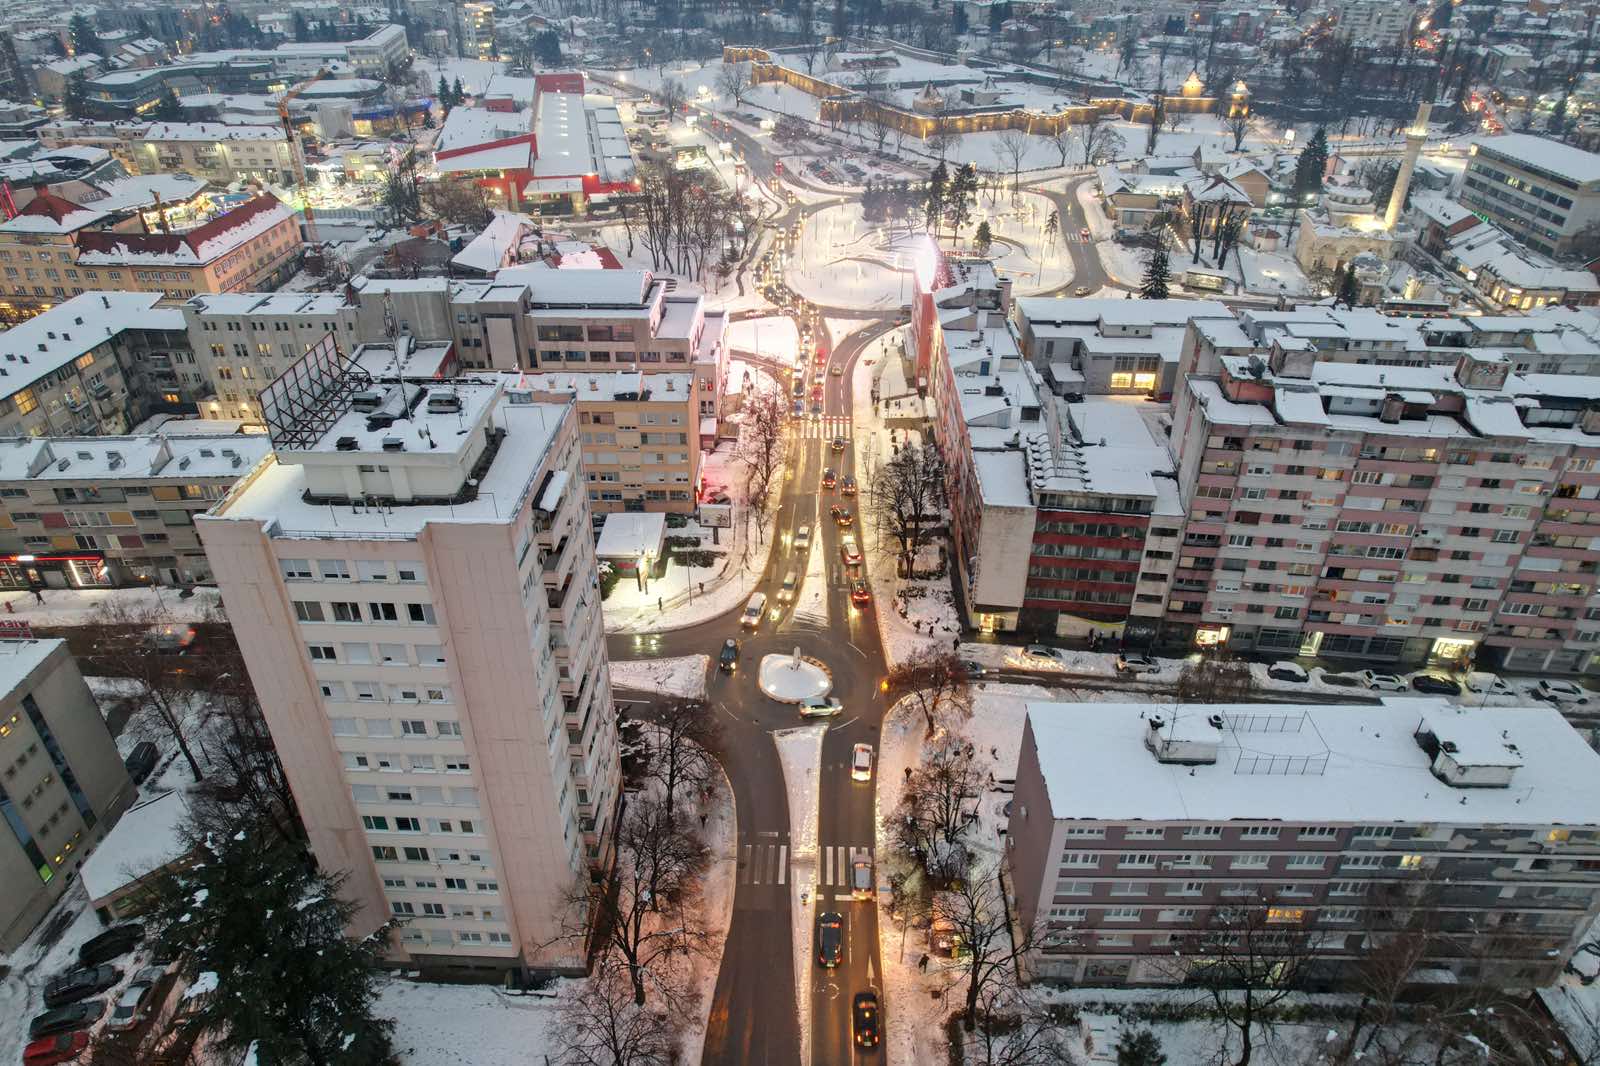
[1027,696,1600,826]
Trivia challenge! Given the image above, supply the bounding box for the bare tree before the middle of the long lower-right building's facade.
[1168,898,1312,1066]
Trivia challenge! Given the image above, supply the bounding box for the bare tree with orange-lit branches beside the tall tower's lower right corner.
[563,795,714,1008]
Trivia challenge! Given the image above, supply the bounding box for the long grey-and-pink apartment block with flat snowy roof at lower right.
[1006,698,1600,989]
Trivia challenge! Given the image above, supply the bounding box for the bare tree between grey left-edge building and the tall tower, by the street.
[91,600,205,781]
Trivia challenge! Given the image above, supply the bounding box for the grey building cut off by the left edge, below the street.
[0,640,138,951]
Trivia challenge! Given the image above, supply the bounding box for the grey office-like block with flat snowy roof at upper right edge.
[1461,133,1600,256]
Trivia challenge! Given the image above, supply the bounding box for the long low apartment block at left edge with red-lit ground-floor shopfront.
[0,434,270,589]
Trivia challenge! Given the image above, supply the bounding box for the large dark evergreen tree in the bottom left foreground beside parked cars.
[147,828,394,1066]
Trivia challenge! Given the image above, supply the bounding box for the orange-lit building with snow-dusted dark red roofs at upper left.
[0,194,301,309]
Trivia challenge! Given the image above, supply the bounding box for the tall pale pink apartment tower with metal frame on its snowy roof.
[197,339,621,973]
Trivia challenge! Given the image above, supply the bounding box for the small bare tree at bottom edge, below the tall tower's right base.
[555,952,683,1066]
